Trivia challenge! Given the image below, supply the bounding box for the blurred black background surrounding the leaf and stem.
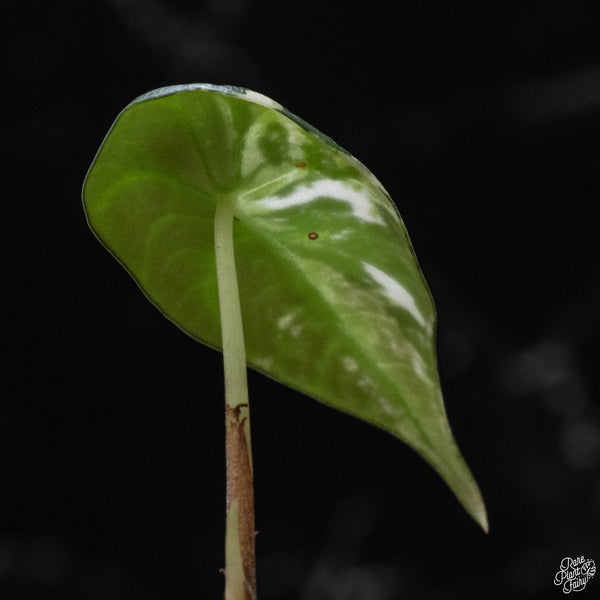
[0,0,600,600]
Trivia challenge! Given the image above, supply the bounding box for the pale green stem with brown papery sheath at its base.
[215,197,256,600]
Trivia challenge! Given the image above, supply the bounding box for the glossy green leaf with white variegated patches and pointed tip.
[83,84,487,529]
